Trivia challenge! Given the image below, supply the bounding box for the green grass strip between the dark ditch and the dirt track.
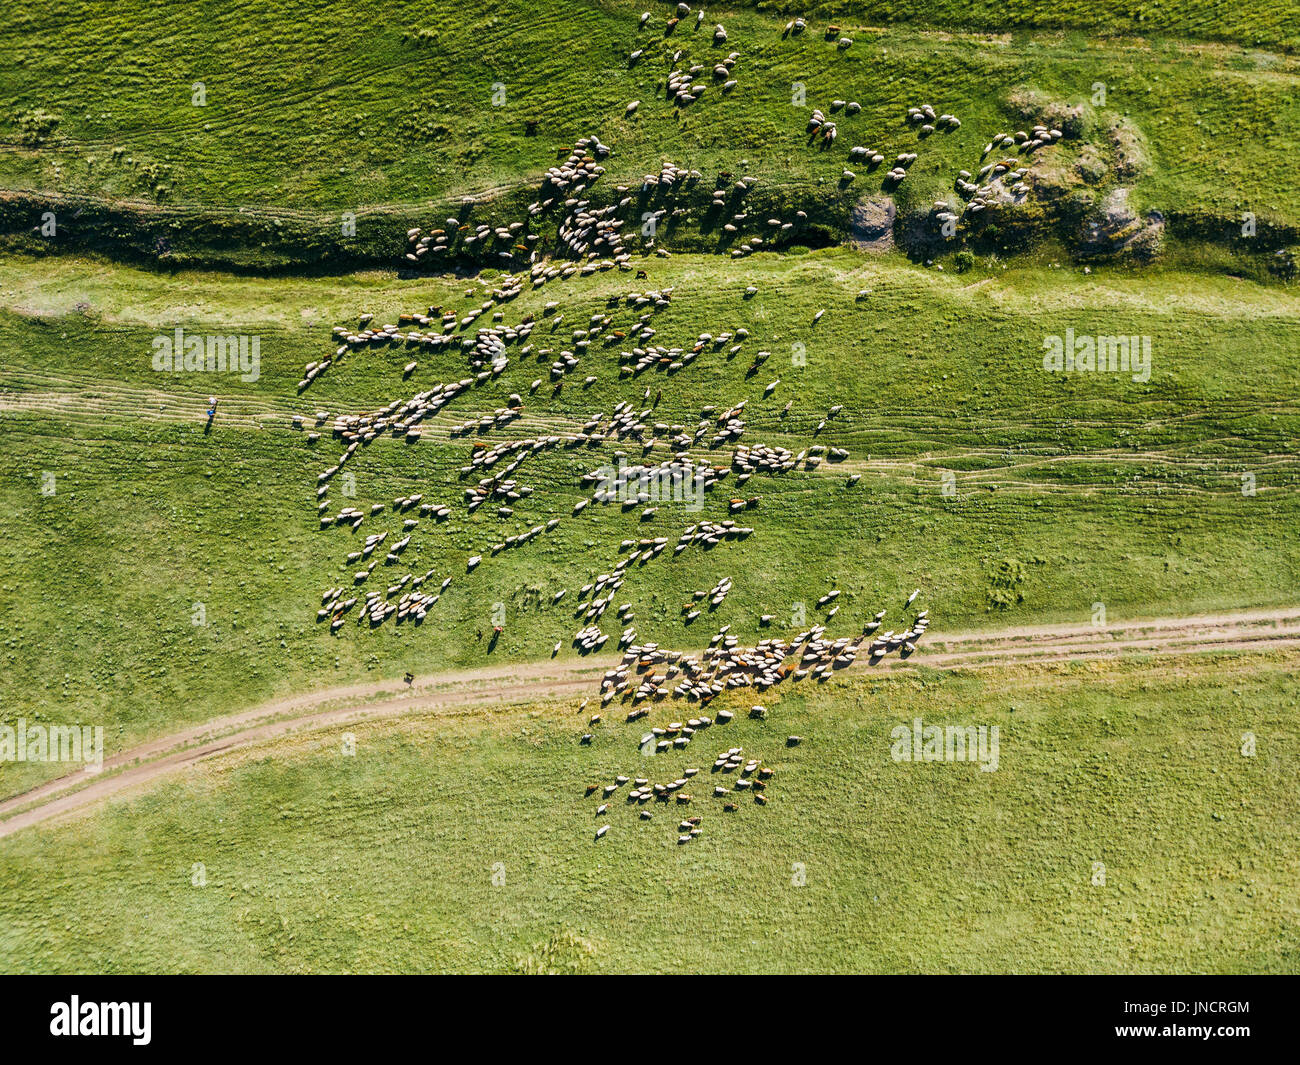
[0,251,1300,793]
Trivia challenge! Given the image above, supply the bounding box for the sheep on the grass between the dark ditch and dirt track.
[293,257,848,637]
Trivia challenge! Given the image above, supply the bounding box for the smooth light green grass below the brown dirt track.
[0,657,1300,973]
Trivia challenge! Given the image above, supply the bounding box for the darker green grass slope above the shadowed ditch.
[0,0,1300,268]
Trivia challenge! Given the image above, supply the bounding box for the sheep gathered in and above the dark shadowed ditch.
[387,3,1062,287]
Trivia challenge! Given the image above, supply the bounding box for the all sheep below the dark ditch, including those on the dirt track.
[294,206,928,843]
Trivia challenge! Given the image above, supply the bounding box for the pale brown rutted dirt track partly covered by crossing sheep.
[0,607,1300,839]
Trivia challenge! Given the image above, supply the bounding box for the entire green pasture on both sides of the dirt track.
[0,0,1300,973]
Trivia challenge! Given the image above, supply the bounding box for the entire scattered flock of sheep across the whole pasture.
[294,4,1045,844]
